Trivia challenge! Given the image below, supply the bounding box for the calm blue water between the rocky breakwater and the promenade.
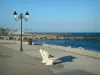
[33,40,100,52]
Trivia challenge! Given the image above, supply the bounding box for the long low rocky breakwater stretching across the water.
[0,34,100,40]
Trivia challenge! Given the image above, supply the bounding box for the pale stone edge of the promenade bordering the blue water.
[43,44,100,59]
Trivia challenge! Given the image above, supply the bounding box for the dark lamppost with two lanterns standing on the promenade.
[13,11,29,51]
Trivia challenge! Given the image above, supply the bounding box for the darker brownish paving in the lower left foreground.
[0,44,53,75]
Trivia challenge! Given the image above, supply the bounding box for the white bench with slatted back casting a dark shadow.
[40,49,60,65]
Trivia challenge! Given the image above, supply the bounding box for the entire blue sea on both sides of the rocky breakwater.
[34,33,100,52]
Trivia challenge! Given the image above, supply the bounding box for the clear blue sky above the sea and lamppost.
[0,0,100,32]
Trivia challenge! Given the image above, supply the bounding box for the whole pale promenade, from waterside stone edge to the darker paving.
[0,40,100,75]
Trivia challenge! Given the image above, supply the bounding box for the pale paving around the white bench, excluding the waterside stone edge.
[3,44,100,75]
